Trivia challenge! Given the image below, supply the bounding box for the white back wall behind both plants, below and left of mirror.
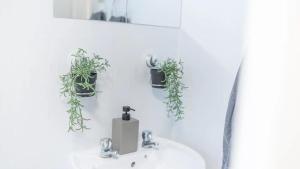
[0,0,177,169]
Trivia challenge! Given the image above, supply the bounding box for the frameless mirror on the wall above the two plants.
[53,0,181,28]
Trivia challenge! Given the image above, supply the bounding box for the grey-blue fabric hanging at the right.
[222,70,240,169]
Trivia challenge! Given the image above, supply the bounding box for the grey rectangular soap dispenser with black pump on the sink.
[112,106,139,155]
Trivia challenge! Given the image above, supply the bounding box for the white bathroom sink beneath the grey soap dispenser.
[71,138,205,169]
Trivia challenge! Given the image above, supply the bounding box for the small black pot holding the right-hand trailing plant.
[150,68,166,88]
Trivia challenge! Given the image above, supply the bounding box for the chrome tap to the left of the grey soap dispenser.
[100,138,119,159]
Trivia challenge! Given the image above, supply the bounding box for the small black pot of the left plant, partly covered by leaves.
[75,73,97,97]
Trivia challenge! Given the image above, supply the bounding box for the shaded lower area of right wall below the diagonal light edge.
[173,32,235,169]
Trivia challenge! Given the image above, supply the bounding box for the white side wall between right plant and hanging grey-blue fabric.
[173,0,246,169]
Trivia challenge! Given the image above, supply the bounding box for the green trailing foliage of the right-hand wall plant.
[160,58,186,121]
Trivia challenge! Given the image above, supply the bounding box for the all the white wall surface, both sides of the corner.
[0,0,244,169]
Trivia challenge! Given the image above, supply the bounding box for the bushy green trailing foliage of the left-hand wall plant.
[60,48,110,132]
